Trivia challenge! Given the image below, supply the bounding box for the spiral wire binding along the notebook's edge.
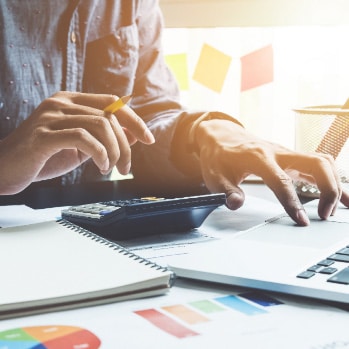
[57,219,175,286]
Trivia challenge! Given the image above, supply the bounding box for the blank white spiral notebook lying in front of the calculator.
[0,220,174,319]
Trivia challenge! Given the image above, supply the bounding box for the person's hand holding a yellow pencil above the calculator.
[0,92,154,194]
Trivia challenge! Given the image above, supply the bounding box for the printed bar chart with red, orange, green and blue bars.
[134,292,283,339]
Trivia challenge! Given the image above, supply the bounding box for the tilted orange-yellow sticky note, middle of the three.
[193,44,232,92]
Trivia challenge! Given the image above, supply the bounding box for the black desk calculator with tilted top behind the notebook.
[62,193,225,240]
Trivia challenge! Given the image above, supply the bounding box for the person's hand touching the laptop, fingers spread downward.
[195,120,349,225]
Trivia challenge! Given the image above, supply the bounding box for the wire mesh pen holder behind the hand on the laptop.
[295,105,349,197]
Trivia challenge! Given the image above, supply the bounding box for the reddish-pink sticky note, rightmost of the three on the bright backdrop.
[241,45,274,91]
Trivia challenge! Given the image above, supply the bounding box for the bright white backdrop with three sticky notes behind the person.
[160,0,349,148]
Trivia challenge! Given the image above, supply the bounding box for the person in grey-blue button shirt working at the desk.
[0,0,349,225]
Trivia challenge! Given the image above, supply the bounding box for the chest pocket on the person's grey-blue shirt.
[83,24,139,96]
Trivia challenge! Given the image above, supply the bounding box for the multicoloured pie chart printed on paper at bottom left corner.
[0,325,101,349]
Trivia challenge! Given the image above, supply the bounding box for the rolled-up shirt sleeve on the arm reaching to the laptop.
[131,0,242,194]
